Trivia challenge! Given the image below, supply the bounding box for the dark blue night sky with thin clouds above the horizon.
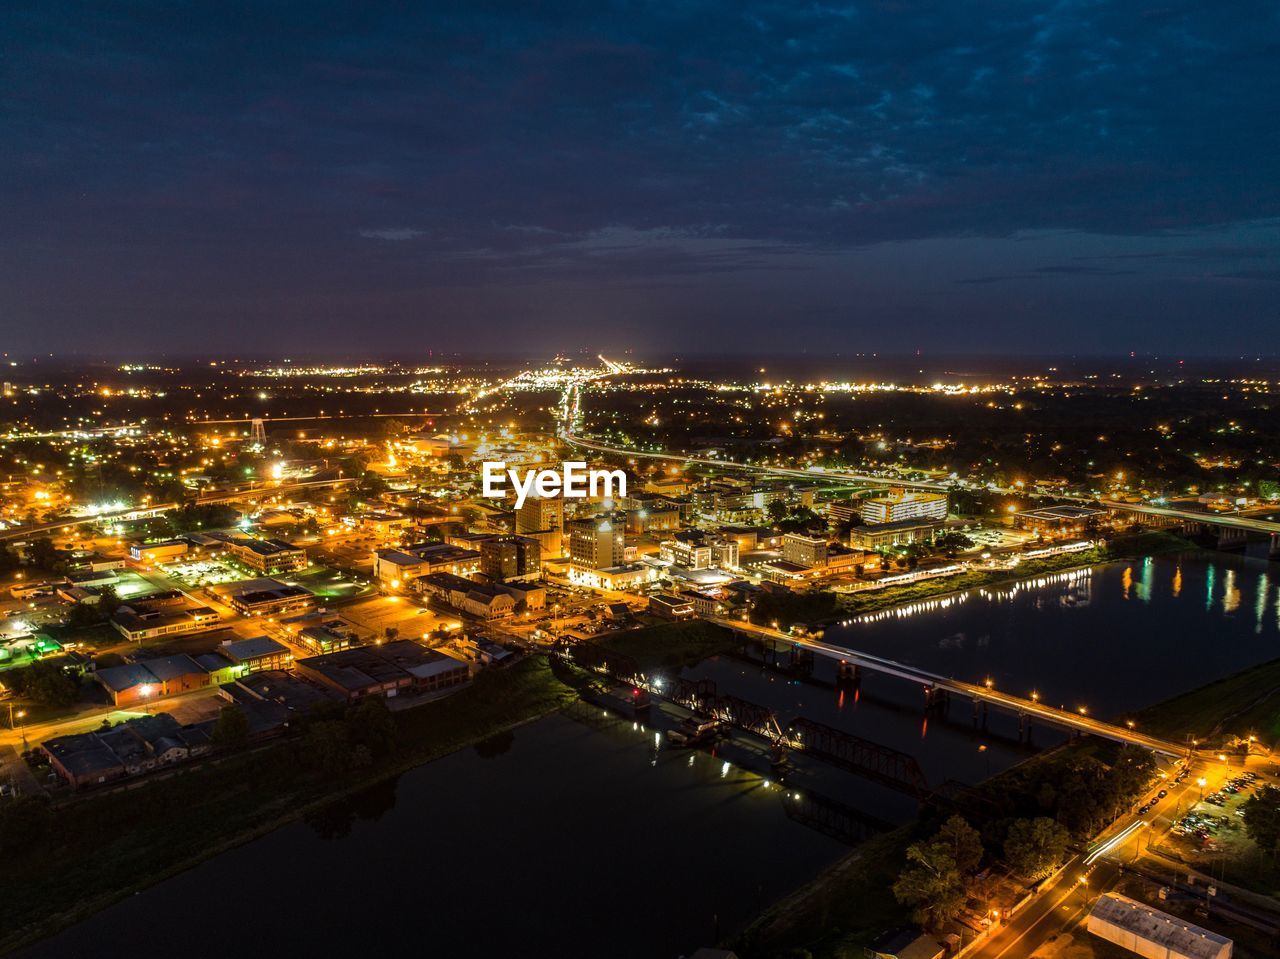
[0,0,1280,356]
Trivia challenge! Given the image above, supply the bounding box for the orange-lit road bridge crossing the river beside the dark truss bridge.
[710,618,1187,757]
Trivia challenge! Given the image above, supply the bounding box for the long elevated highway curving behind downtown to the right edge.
[561,431,1280,537]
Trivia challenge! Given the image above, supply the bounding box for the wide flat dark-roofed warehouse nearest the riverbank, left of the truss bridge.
[294,639,471,703]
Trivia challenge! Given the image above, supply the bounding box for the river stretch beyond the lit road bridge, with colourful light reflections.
[824,553,1280,716]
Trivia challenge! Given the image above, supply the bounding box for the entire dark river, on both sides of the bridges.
[27,554,1280,959]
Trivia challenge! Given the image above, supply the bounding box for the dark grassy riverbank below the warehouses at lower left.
[0,658,576,951]
